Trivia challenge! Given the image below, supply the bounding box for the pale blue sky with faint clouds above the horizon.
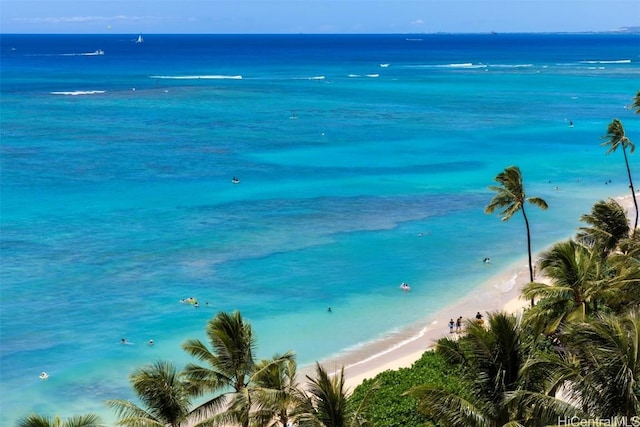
[0,0,640,34]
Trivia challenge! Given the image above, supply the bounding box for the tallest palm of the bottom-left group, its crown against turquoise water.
[182,311,294,427]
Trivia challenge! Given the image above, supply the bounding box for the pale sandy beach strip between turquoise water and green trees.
[312,195,635,393]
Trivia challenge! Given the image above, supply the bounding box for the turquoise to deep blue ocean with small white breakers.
[0,34,640,425]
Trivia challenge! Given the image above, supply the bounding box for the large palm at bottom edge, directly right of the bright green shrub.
[407,312,558,427]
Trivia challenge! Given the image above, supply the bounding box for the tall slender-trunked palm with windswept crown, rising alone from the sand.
[484,166,548,307]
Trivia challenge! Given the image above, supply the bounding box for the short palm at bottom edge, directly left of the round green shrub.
[296,362,368,427]
